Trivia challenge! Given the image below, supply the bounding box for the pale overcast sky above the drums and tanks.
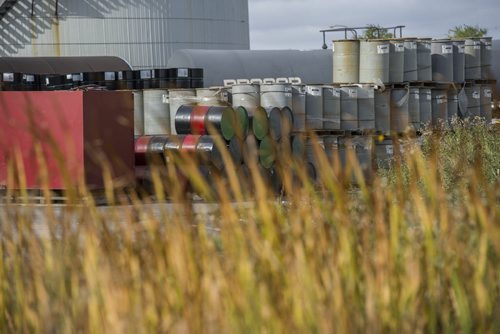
[249,0,500,49]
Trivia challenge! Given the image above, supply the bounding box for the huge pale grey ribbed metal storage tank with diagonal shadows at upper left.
[0,0,250,68]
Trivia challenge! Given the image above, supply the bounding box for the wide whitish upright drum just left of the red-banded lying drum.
[143,89,170,135]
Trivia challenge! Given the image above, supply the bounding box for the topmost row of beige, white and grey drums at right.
[333,37,494,83]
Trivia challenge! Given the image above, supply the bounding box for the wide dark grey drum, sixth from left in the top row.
[431,39,453,82]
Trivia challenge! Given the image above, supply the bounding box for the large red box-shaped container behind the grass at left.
[0,91,134,189]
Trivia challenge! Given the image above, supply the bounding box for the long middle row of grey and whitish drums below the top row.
[133,84,492,139]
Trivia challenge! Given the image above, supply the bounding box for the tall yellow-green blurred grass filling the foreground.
[0,124,500,333]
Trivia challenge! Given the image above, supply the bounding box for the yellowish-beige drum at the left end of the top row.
[332,40,359,83]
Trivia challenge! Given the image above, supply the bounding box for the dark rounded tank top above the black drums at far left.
[0,57,130,74]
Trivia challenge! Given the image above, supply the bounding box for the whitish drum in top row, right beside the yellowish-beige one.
[359,39,390,83]
